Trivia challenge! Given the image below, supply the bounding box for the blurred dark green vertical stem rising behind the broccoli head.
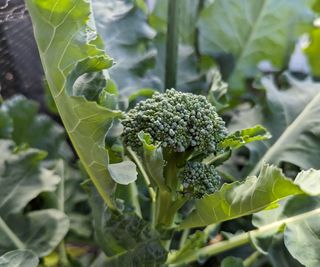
[165,0,180,89]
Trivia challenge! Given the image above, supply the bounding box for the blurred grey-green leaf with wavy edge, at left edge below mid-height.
[0,140,60,218]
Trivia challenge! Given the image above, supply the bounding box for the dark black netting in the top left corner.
[0,0,43,109]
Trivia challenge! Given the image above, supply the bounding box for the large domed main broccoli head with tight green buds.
[122,89,227,152]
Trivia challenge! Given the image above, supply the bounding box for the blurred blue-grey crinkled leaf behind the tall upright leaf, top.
[92,0,160,96]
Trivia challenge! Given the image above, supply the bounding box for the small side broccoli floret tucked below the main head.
[179,161,221,198]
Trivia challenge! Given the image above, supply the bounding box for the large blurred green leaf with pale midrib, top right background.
[198,0,313,92]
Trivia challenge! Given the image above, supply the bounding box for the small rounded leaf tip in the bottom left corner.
[0,250,39,267]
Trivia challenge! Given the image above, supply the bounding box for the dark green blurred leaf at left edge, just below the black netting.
[1,95,73,159]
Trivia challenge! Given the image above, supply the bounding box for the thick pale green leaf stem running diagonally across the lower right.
[167,208,320,267]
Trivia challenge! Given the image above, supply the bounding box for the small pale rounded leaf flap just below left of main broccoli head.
[108,160,138,185]
